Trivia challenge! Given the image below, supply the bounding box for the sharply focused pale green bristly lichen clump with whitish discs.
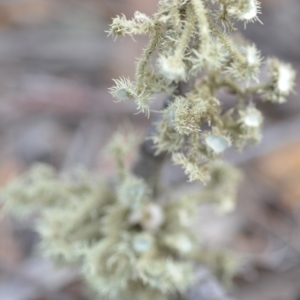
[110,0,295,182]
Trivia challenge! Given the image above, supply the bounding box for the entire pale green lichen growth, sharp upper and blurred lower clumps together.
[2,0,295,300]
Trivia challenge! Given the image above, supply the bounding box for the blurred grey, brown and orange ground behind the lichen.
[0,0,300,300]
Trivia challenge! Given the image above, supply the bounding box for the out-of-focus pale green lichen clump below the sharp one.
[2,165,198,300]
